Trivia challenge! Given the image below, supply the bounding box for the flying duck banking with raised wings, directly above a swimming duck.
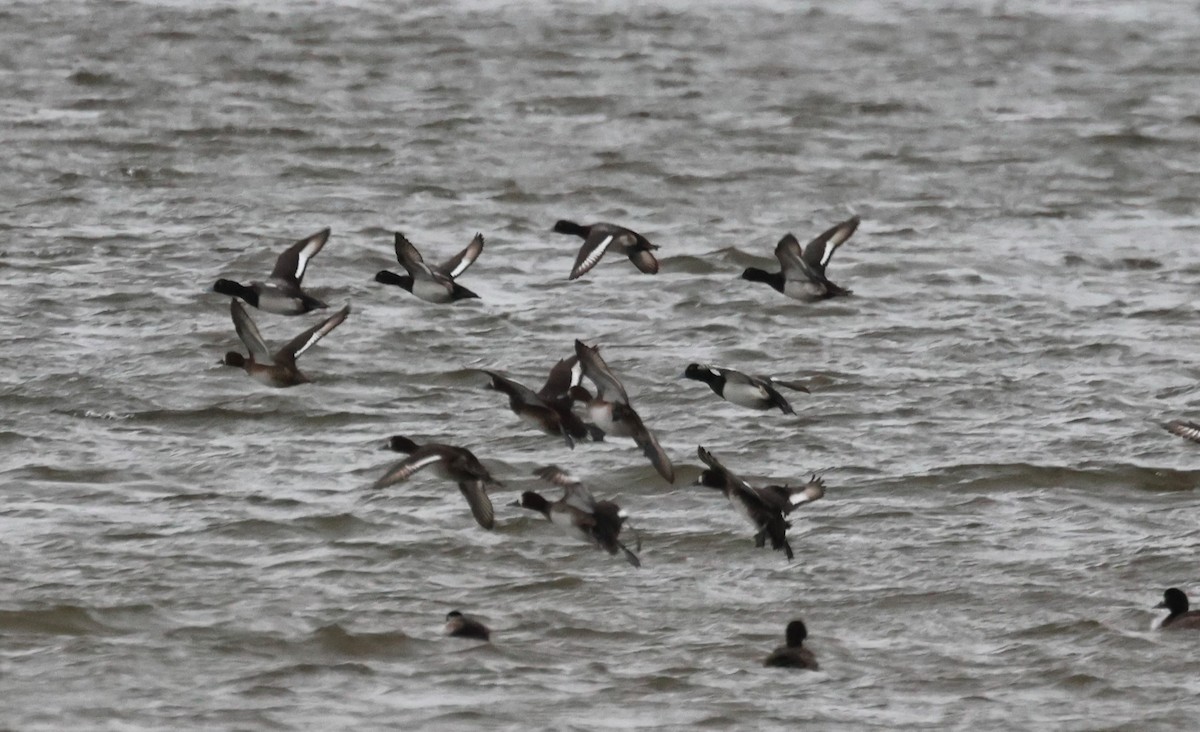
[696,448,824,560]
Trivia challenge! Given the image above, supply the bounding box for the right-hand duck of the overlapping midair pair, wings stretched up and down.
[570,341,674,482]
